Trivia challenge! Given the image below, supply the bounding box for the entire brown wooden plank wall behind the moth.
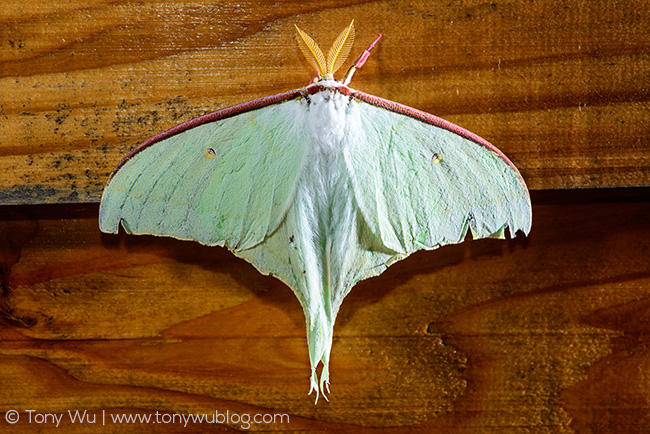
[0,0,650,433]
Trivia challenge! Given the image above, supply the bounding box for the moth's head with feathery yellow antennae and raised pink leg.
[296,20,381,85]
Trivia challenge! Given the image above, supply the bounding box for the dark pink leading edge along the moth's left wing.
[109,88,305,182]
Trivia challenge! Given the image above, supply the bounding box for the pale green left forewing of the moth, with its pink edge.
[99,91,305,250]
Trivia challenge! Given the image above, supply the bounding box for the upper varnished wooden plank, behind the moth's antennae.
[0,0,650,204]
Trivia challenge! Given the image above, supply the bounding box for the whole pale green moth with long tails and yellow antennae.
[99,21,531,401]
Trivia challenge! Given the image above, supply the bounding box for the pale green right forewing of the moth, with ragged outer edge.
[344,92,531,253]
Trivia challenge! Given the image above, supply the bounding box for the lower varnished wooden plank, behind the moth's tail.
[0,190,650,433]
